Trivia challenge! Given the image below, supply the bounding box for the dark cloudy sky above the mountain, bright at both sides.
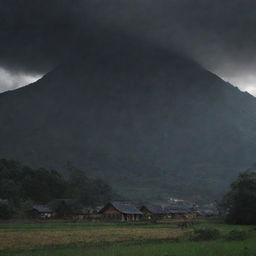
[0,0,256,95]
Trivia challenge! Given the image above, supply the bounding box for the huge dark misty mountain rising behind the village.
[0,38,256,200]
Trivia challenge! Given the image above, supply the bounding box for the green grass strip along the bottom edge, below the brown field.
[0,237,256,256]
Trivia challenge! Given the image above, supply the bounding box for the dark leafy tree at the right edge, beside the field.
[222,166,256,225]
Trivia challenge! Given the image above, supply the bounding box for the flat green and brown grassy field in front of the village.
[0,222,256,256]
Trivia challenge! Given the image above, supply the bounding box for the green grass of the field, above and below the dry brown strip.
[0,222,256,256]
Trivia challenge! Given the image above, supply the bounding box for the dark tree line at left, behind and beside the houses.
[0,159,114,218]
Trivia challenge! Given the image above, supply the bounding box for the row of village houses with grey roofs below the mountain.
[30,199,215,222]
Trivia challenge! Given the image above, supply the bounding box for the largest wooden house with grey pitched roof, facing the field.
[99,201,142,221]
